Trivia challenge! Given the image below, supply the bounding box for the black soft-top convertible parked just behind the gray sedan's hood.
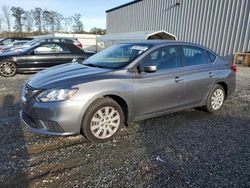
[0,42,94,77]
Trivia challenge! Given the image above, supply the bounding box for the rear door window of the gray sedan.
[182,46,209,66]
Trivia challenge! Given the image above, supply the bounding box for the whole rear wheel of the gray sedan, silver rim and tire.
[205,85,225,113]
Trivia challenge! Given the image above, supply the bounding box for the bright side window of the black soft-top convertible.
[34,44,69,54]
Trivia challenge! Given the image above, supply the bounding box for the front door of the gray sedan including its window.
[134,46,185,118]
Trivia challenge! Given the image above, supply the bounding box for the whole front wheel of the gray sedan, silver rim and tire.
[82,98,124,143]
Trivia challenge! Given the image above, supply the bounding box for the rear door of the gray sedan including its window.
[181,46,214,106]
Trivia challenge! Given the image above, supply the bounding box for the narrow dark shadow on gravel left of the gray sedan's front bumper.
[0,94,28,187]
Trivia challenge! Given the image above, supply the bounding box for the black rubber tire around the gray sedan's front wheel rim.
[81,97,124,143]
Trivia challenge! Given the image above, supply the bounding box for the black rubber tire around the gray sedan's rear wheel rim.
[204,84,226,113]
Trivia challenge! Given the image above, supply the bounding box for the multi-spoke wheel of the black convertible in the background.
[0,60,17,77]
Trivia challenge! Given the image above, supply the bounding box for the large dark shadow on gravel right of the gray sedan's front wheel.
[138,110,250,187]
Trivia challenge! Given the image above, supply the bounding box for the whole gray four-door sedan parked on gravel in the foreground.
[20,40,237,142]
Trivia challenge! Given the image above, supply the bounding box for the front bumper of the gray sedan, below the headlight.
[20,100,84,136]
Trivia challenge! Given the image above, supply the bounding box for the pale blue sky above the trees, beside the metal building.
[0,0,132,31]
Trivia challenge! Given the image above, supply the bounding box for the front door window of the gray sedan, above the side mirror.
[140,46,180,70]
